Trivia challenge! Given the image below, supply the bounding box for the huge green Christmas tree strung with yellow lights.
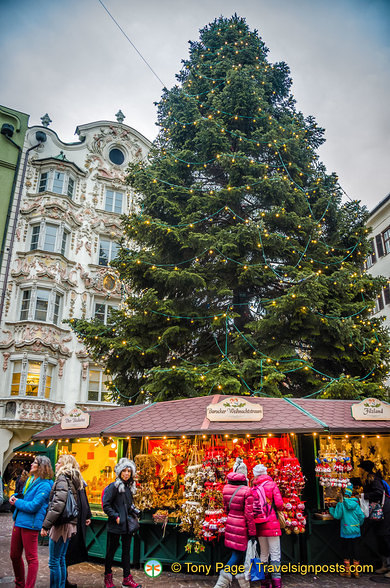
[71,15,389,404]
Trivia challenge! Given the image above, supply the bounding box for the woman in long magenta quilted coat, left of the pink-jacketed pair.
[214,458,256,588]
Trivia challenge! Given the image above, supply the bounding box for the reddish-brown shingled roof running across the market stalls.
[33,394,390,440]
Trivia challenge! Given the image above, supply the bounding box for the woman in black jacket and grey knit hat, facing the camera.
[103,457,141,588]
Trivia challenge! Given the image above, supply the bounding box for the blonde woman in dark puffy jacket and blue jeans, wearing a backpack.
[41,454,83,588]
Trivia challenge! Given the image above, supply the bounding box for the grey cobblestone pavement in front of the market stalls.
[0,513,390,588]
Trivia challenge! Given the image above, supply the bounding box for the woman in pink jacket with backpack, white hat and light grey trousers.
[252,464,283,588]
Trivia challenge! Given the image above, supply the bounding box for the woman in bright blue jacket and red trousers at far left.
[9,455,53,588]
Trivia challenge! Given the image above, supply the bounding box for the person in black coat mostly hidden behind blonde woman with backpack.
[65,483,92,588]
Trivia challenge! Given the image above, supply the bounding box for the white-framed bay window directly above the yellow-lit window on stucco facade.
[18,284,64,327]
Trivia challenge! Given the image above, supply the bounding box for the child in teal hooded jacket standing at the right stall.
[329,484,364,578]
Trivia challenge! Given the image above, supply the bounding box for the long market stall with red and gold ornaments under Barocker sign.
[34,395,390,563]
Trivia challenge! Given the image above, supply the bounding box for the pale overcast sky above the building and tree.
[0,0,390,209]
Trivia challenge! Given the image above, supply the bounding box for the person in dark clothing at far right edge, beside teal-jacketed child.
[359,459,390,578]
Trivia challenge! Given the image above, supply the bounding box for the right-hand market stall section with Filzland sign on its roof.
[296,399,390,564]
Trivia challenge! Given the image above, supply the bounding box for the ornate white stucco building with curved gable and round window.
[0,112,150,472]
